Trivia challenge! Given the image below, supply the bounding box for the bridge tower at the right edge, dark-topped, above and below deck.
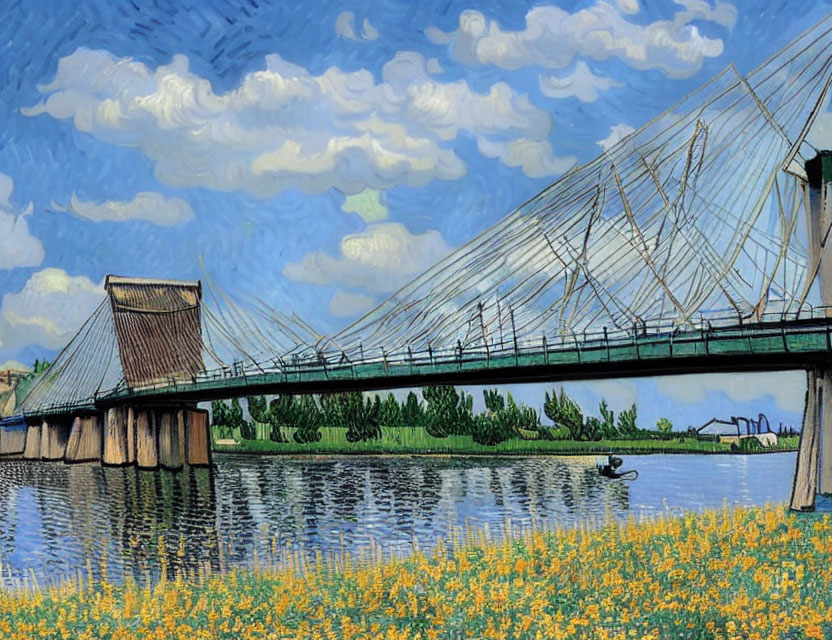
[789,151,832,511]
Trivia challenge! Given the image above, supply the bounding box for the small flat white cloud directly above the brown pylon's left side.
[58,191,194,227]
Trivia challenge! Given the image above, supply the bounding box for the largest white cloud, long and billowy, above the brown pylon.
[21,49,575,198]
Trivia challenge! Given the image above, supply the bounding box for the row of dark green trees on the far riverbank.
[211,386,672,445]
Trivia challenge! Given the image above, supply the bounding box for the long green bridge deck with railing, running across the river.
[22,318,832,415]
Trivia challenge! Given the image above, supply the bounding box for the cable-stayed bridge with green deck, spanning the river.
[11,16,832,507]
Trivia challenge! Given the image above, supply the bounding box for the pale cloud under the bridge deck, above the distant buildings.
[658,371,806,413]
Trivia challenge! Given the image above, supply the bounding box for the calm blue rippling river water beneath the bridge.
[0,453,796,583]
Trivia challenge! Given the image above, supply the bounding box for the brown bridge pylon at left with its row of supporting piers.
[23,276,211,469]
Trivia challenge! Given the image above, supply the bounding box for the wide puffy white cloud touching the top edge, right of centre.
[426,0,737,78]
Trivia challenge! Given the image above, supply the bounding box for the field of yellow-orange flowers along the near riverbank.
[0,506,832,640]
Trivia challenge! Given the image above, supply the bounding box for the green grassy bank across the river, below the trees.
[214,427,798,455]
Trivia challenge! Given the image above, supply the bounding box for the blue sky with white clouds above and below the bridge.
[0,0,832,426]
